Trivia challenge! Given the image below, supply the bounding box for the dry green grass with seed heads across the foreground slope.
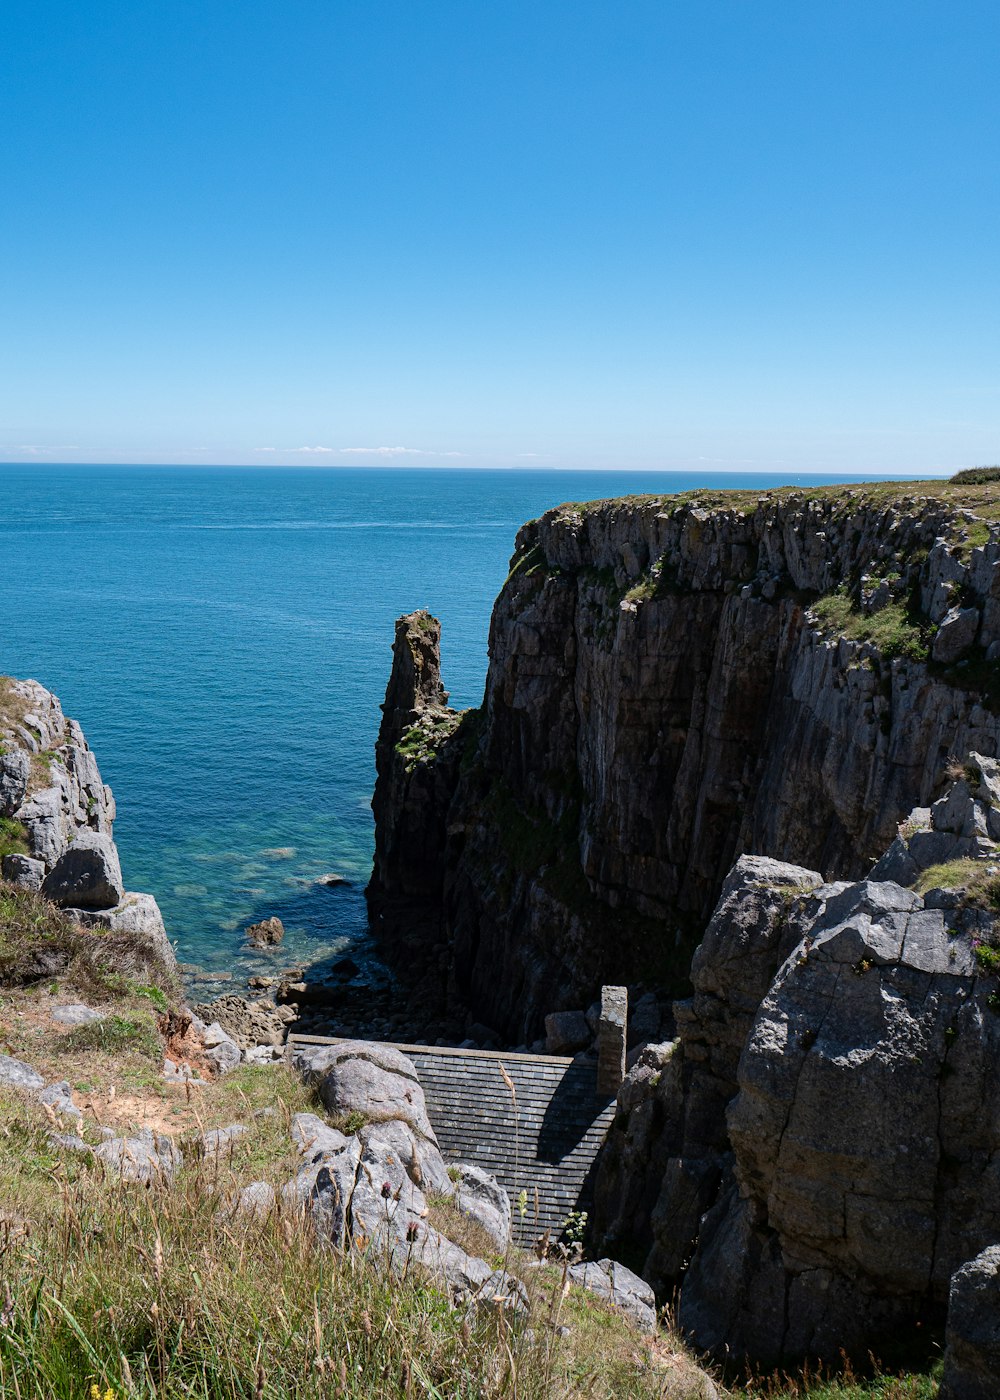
[0,1092,717,1400]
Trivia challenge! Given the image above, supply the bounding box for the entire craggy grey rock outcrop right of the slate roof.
[595,755,1000,1366]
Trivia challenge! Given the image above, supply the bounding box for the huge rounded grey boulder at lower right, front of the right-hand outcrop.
[679,881,1000,1365]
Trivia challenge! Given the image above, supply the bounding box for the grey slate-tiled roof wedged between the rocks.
[290,1036,615,1245]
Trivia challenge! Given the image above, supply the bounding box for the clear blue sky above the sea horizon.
[0,0,1000,472]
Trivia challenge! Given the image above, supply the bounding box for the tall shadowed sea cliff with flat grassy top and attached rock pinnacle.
[370,484,1000,1040]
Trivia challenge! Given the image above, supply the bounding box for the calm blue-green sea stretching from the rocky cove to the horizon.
[0,465,901,972]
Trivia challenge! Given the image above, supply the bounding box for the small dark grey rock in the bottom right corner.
[938,1245,1000,1400]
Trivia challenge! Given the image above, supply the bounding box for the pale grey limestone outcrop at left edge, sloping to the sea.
[0,676,176,972]
